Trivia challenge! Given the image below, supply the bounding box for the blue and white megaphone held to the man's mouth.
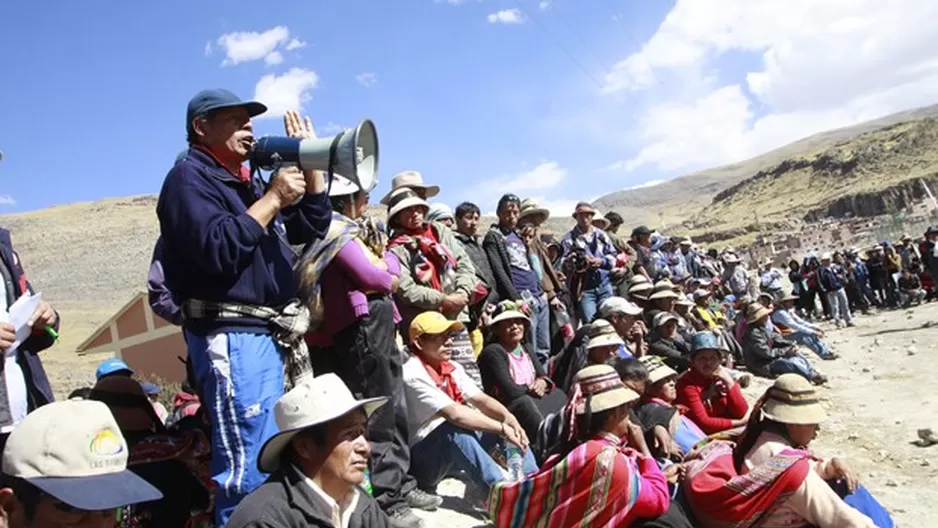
[251,119,378,193]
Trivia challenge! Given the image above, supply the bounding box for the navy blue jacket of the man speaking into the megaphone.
[156,148,332,334]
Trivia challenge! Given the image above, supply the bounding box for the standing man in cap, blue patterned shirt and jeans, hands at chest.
[560,202,618,323]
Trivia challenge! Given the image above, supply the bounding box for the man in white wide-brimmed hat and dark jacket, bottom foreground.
[228,374,391,528]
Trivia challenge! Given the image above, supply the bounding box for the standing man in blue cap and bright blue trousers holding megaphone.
[156,89,332,526]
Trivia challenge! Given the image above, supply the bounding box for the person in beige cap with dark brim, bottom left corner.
[0,400,162,528]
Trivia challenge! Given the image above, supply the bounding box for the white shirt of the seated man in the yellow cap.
[403,350,482,445]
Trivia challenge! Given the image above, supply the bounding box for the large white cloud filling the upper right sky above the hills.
[603,0,938,171]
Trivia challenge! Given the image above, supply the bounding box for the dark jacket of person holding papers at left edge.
[0,229,60,426]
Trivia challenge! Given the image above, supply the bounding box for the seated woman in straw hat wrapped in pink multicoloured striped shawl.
[489,365,690,528]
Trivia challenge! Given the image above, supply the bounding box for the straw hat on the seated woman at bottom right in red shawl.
[762,374,827,425]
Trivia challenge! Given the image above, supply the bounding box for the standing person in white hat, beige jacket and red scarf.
[388,188,487,385]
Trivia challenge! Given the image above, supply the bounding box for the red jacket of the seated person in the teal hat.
[676,369,749,435]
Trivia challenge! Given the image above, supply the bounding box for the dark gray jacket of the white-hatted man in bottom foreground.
[227,465,391,528]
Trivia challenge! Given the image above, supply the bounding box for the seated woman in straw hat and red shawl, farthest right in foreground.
[684,374,893,528]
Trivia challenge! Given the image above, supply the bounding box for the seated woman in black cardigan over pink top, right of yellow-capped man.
[478,301,567,446]
